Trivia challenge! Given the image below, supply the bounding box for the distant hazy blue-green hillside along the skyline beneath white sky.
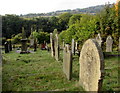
[20,5,105,17]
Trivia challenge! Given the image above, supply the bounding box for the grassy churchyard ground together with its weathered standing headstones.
[2,30,120,92]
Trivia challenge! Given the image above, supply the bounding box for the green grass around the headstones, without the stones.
[2,50,120,91]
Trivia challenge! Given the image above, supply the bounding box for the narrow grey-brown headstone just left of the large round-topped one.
[63,44,72,80]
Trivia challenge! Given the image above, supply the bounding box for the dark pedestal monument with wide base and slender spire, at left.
[20,27,28,54]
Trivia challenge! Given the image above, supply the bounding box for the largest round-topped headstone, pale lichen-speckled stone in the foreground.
[79,39,104,91]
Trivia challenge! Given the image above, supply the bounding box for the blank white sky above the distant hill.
[0,0,117,15]
